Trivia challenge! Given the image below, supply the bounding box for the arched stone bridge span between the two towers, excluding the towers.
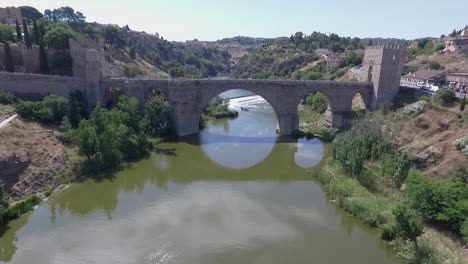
[100,79,373,136]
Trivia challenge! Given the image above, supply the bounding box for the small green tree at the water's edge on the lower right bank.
[393,205,423,251]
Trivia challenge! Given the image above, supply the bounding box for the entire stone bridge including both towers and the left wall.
[0,40,406,136]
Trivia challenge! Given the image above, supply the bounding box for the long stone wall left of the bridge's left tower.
[0,72,85,100]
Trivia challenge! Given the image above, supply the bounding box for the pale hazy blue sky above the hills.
[0,0,468,40]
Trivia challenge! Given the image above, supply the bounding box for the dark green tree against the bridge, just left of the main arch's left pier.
[145,95,171,136]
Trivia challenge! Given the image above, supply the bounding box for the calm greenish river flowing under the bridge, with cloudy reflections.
[0,89,399,264]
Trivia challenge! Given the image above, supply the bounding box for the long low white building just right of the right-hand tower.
[400,70,446,88]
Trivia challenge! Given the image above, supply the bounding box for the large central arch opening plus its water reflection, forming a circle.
[194,90,279,170]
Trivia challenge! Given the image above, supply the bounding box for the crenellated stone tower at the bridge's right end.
[361,45,406,109]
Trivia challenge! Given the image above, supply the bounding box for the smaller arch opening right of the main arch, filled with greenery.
[297,92,333,133]
